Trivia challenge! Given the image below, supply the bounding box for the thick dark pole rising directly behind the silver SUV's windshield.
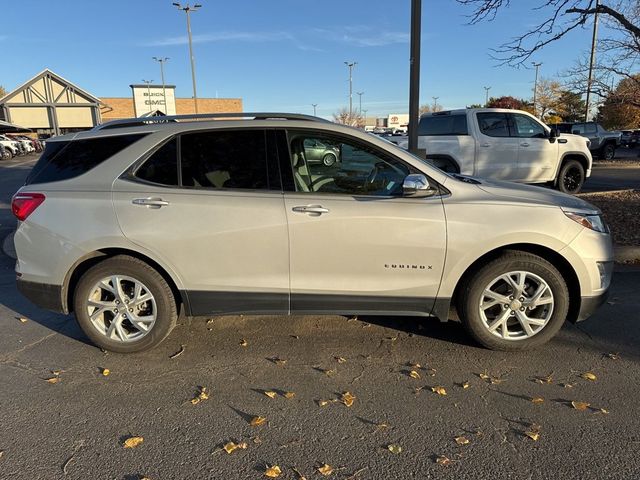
[409,0,422,153]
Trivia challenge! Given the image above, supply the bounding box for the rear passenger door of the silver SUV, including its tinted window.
[113,129,289,315]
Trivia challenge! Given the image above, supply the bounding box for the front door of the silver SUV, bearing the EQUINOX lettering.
[278,130,446,314]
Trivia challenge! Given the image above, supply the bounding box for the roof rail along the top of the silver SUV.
[93,112,331,130]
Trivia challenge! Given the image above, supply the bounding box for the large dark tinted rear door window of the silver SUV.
[180,130,269,190]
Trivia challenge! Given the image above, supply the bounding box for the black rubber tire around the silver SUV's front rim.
[457,251,569,351]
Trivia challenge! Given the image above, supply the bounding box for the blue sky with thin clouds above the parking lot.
[0,0,591,117]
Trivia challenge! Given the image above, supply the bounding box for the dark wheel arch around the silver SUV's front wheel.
[448,243,581,323]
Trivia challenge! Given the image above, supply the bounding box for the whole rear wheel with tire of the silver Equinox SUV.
[74,255,178,353]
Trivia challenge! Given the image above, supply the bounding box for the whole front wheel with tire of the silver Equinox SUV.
[457,251,569,350]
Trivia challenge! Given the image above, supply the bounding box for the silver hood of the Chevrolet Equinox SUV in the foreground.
[460,175,600,212]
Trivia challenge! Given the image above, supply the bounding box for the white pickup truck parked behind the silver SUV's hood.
[398,108,593,193]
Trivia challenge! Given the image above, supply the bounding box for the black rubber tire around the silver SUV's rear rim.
[73,255,178,353]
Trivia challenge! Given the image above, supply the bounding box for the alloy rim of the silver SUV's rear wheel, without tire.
[85,275,158,343]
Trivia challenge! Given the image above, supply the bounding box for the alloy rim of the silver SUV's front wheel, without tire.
[478,270,555,341]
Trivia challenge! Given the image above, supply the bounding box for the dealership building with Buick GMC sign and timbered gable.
[0,69,242,138]
